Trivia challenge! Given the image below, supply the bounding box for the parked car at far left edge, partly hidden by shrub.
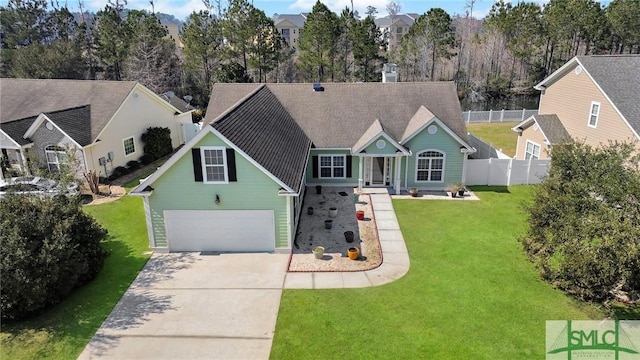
[0,176,78,198]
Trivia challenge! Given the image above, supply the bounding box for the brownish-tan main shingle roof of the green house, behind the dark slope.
[206,82,468,149]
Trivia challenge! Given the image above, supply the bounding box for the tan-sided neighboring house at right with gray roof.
[513,55,640,159]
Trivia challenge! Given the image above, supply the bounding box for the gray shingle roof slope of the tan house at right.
[577,55,640,133]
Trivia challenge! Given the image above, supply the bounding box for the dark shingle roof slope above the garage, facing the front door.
[207,86,311,192]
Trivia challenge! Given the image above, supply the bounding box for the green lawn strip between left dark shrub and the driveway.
[0,196,149,359]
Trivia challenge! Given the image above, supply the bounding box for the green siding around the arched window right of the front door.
[401,125,465,189]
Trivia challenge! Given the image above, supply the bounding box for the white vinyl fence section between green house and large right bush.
[465,159,551,186]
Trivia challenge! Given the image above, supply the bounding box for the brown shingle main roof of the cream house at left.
[0,78,136,141]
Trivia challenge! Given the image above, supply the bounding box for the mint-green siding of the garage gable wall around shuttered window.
[149,134,288,248]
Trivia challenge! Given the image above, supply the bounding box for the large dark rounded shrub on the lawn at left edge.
[0,195,107,320]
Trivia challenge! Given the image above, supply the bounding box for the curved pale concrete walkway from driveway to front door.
[284,188,409,289]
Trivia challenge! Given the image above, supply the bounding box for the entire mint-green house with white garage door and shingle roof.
[132,82,475,252]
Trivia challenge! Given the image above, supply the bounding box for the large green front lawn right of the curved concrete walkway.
[271,186,605,359]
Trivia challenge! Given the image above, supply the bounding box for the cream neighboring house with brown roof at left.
[0,79,191,176]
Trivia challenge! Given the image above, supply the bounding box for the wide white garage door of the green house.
[164,210,275,251]
